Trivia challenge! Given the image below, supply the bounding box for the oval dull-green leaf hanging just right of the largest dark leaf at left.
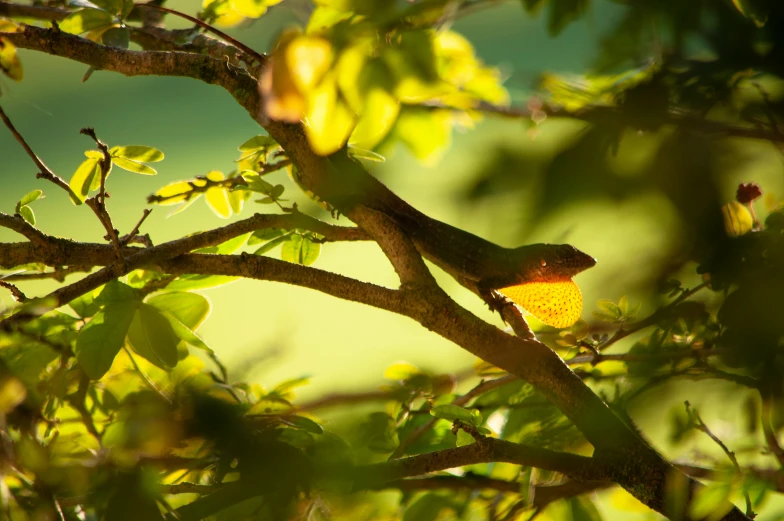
[128,304,180,370]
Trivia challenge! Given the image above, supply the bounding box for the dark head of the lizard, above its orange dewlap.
[514,244,596,282]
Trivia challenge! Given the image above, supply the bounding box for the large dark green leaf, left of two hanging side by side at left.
[74,301,137,380]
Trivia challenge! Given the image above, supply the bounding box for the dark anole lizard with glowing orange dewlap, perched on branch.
[136,4,596,328]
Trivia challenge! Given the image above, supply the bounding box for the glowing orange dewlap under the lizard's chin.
[498,279,583,328]
